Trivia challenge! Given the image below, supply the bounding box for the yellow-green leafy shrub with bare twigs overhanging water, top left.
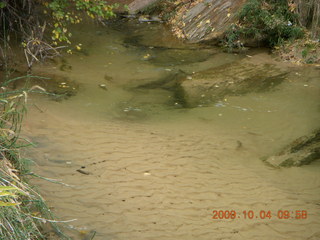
[0,0,118,68]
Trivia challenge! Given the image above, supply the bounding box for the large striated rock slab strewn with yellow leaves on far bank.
[170,0,246,42]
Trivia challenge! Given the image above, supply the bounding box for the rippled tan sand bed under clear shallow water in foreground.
[27,114,320,240]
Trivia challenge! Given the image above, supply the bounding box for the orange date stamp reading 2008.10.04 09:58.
[212,210,308,220]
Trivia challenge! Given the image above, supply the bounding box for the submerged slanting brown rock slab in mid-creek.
[181,58,287,107]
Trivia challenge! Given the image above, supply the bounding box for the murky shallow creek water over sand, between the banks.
[24,20,320,240]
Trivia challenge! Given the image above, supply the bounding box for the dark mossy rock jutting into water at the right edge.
[263,129,320,167]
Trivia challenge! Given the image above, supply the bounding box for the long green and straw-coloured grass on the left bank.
[0,79,65,240]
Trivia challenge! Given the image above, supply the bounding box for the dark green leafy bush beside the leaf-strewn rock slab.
[226,0,304,48]
